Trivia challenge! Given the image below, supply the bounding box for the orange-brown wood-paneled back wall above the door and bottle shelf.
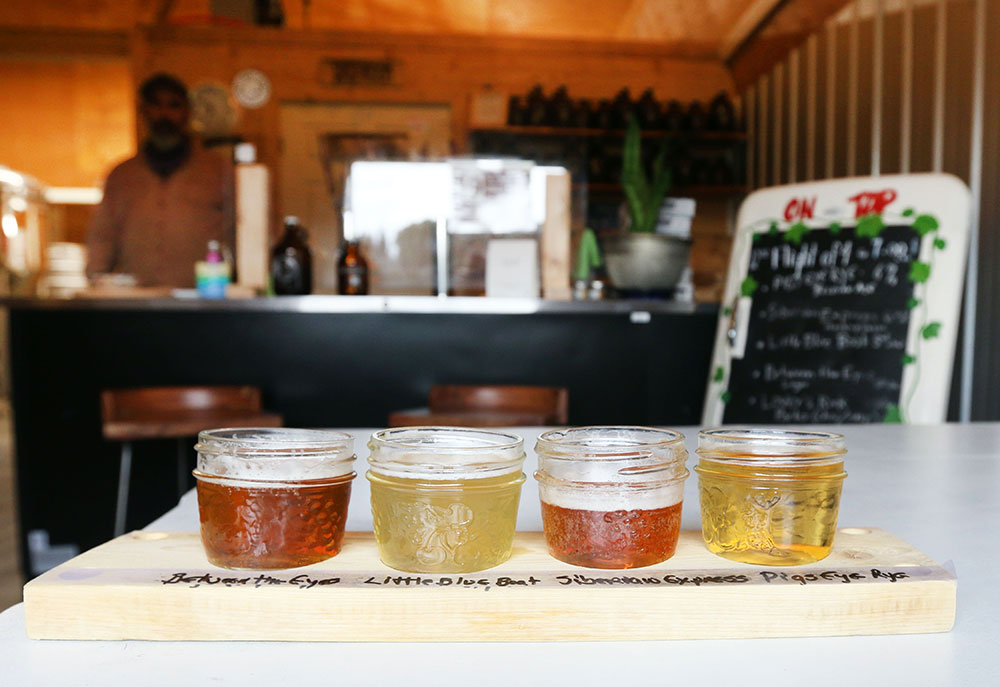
[133,27,733,241]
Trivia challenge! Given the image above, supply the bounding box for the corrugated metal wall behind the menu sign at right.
[744,0,1000,420]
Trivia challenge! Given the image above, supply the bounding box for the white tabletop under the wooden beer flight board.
[0,423,1000,687]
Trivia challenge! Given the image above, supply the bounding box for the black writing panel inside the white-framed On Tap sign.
[724,226,920,423]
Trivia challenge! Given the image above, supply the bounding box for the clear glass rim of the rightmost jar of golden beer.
[696,427,847,462]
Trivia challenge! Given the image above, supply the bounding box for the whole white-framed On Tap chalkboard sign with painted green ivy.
[704,174,968,424]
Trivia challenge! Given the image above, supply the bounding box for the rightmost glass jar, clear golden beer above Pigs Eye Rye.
[695,429,847,565]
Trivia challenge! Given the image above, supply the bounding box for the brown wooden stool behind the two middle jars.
[389,384,569,427]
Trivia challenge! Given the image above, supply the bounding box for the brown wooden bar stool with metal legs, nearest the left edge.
[101,386,282,537]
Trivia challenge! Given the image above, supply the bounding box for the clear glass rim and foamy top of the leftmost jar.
[195,427,355,482]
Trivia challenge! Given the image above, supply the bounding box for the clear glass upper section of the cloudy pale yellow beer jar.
[368,427,524,481]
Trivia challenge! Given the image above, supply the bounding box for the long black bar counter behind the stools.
[3,296,718,568]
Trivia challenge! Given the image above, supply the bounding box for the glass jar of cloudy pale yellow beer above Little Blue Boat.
[367,427,525,573]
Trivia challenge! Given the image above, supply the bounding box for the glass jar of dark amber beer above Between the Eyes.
[194,428,355,570]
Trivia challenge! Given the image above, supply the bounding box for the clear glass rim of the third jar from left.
[535,425,687,461]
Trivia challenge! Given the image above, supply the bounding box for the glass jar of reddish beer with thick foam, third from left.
[535,427,688,569]
